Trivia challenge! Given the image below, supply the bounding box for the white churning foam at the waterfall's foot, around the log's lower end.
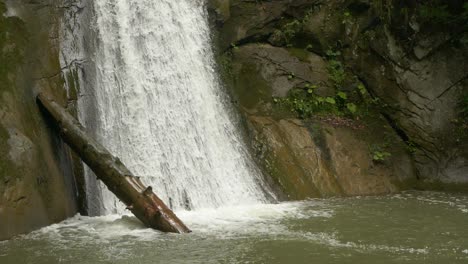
[22,202,333,241]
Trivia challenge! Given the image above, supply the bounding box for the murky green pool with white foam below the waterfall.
[0,192,468,264]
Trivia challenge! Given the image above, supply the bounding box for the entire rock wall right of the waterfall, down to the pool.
[210,0,468,198]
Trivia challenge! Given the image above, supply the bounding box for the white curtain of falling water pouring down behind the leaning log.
[71,0,267,215]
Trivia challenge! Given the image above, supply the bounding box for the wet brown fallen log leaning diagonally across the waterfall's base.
[37,93,190,233]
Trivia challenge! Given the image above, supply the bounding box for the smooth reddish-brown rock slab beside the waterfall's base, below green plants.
[249,116,413,199]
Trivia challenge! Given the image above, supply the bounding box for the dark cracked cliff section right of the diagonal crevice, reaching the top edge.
[305,1,468,184]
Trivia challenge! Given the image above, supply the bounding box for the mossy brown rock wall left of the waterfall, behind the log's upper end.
[0,1,76,240]
